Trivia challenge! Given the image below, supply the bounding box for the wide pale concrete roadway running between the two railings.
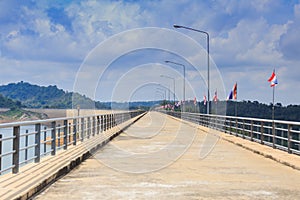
[37,112,300,200]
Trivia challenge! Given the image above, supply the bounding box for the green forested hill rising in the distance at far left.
[0,81,107,109]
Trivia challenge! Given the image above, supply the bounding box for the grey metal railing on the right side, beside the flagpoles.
[162,111,300,155]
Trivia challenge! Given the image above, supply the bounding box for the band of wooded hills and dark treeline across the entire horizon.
[0,81,300,121]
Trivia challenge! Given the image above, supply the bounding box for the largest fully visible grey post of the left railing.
[12,126,20,174]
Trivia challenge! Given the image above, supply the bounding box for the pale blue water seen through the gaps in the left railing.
[0,125,51,173]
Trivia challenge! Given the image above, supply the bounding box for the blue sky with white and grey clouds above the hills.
[0,0,300,105]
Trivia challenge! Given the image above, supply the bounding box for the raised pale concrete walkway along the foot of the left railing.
[0,113,144,200]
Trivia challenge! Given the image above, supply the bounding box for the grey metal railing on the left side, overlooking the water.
[0,110,145,175]
